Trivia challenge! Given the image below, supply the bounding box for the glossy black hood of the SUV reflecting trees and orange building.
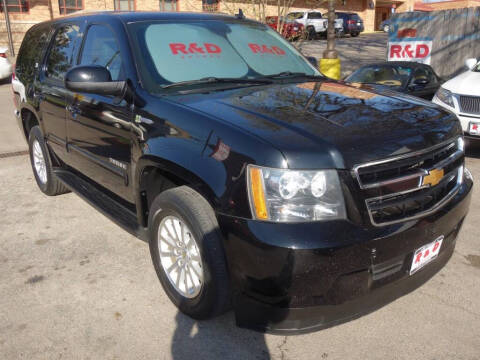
[171,81,461,169]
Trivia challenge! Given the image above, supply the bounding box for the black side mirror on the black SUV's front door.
[65,66,126,96]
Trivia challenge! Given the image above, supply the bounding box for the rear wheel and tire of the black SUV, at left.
[28,125,70,196]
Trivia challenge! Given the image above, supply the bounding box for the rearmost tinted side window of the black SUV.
[15,25,50,84]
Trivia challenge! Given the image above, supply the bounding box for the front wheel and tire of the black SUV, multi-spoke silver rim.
[148,186,230,319]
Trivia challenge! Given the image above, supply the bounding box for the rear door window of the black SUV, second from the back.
[45,25,80,80]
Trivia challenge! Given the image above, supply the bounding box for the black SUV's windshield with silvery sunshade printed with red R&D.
[129,20,320,92]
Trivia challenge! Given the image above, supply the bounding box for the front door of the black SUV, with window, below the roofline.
[67,24,133,202]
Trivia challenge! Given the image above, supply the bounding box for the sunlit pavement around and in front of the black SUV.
[0,71,480,360]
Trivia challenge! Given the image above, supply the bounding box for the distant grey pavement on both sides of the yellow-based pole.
[294,33,388,76]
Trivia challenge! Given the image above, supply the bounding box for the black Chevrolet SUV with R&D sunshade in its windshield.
[14,13,472,332]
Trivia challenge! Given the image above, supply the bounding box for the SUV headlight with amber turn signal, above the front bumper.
[248,165,346,222]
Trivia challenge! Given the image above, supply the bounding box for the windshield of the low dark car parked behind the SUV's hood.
[346,66,412,87]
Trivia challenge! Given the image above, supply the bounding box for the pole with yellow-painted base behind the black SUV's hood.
[320,0,341,80]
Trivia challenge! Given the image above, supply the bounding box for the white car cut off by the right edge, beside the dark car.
[432,59,480,140]
